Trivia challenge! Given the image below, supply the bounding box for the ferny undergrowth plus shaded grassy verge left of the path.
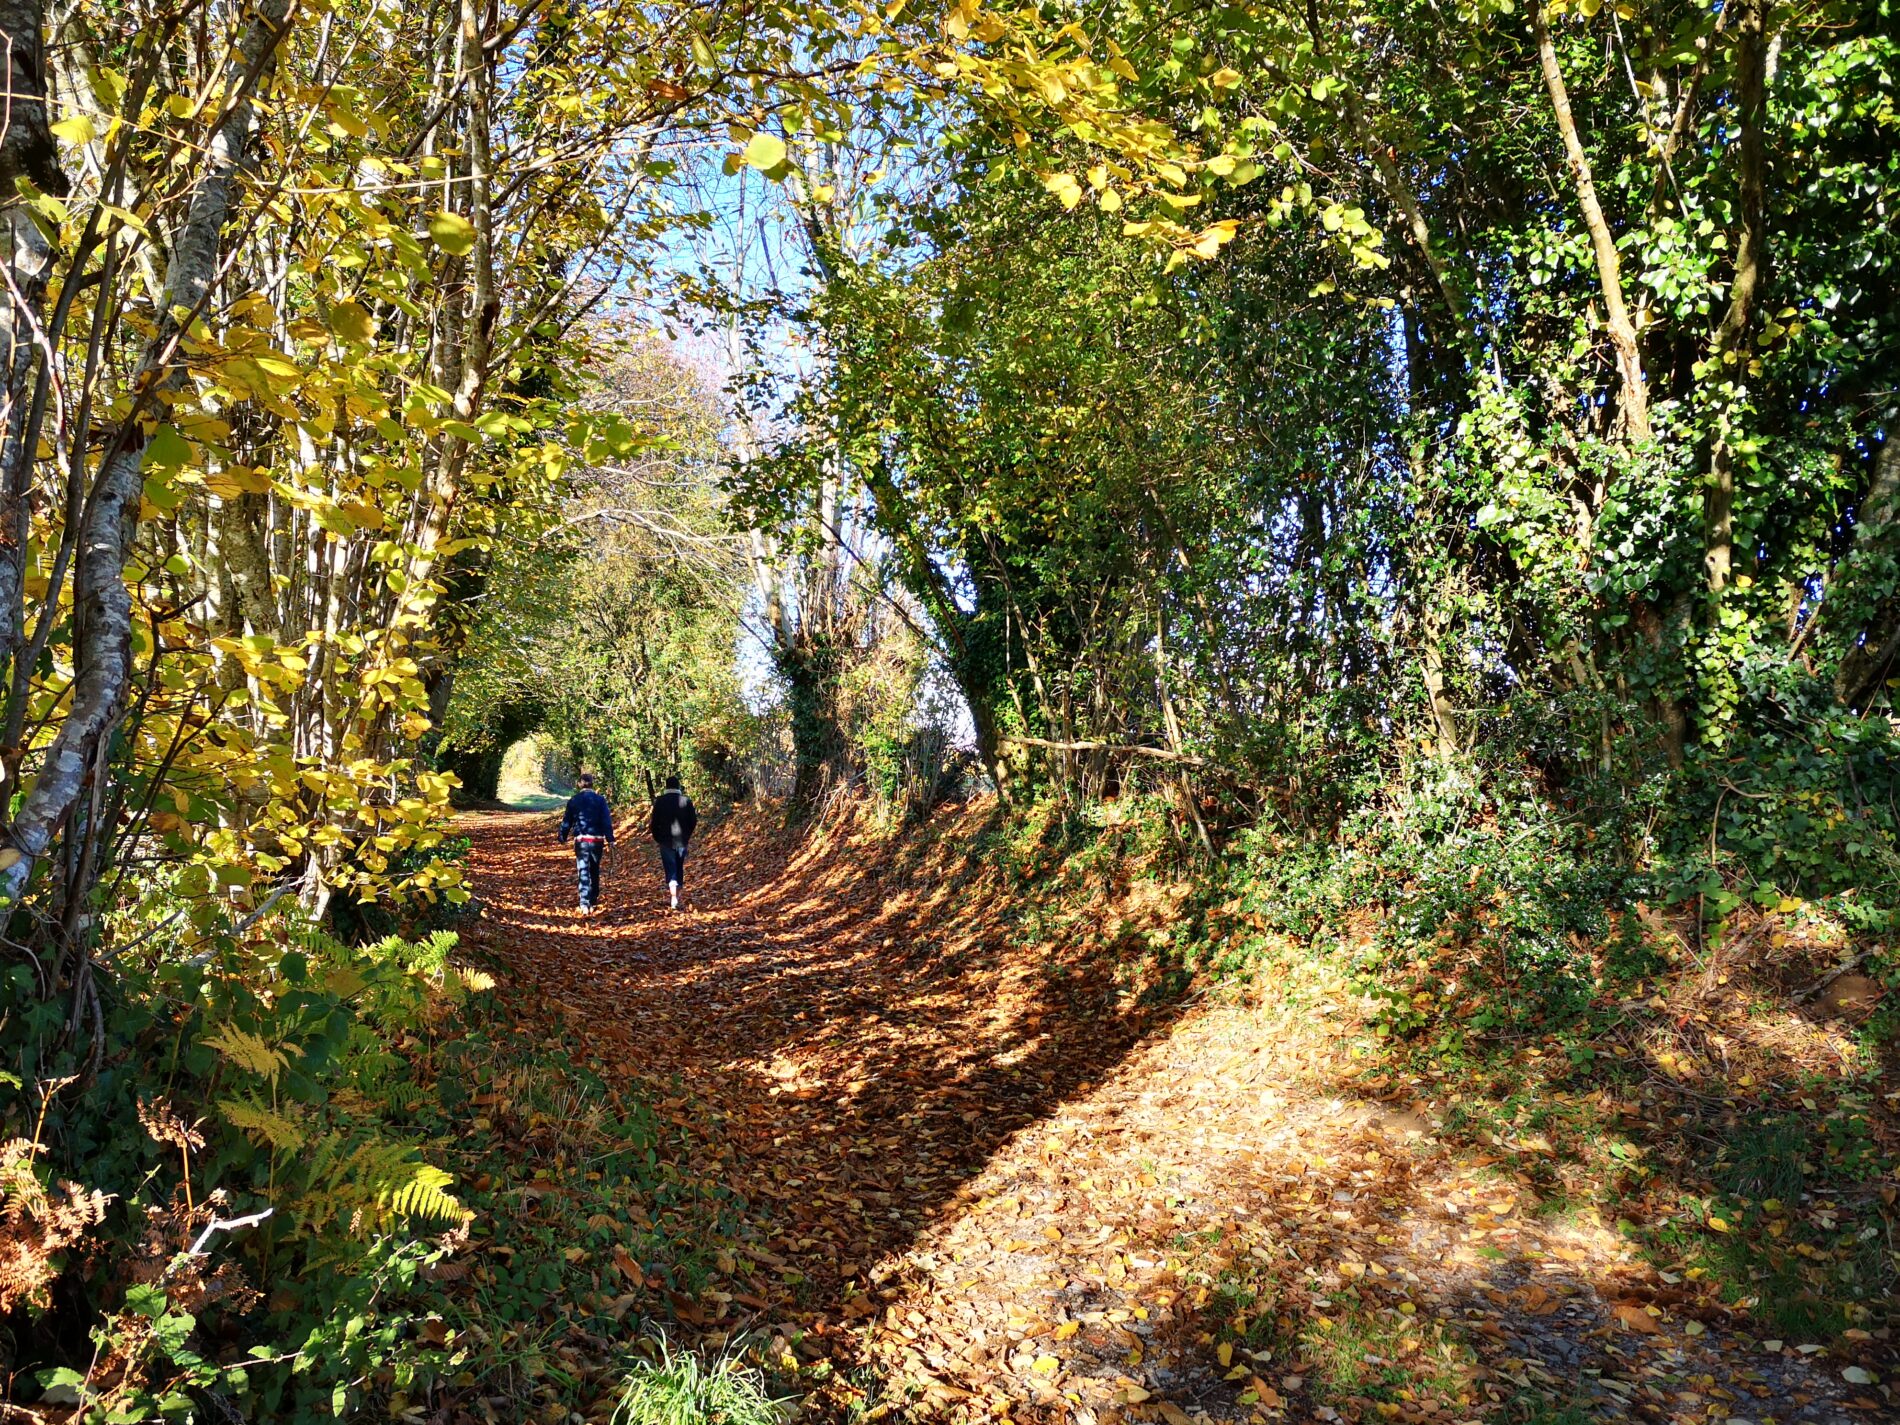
[0,893,751,1425]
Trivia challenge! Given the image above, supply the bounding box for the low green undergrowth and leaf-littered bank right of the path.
[942,741,1900,1341]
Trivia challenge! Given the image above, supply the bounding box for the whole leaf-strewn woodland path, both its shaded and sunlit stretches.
[452,813,1891,1425]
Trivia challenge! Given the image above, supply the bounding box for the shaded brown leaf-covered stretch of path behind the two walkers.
[464,813,1176,1322]
